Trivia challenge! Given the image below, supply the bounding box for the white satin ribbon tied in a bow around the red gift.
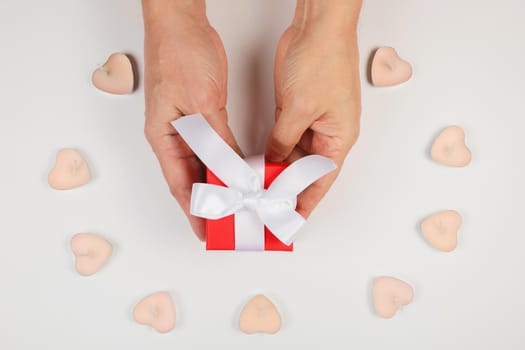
[172,114,336,250]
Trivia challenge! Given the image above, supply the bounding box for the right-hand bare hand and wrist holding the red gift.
[266,0,361,217]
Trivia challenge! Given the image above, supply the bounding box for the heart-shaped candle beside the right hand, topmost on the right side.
[370,47,412,86]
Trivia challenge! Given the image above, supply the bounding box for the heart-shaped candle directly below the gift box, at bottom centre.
[239,295,281,334]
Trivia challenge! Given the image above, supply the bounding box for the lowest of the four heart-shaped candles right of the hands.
[373,276,414,318]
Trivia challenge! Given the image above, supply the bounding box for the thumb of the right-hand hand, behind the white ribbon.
[266,108,312,162]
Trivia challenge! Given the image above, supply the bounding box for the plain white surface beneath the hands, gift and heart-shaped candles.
[0,0,525,350]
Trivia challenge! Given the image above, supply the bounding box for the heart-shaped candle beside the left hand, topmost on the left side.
[91,53,134,95]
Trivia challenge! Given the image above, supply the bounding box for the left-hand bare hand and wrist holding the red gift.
[143,0,240,240]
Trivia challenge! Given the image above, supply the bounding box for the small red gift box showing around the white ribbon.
[206,163,293,251]
